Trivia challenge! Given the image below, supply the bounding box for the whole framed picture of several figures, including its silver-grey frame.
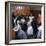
[5,2,45,44]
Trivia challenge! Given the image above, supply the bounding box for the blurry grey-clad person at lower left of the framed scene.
[13,17,27,39]
